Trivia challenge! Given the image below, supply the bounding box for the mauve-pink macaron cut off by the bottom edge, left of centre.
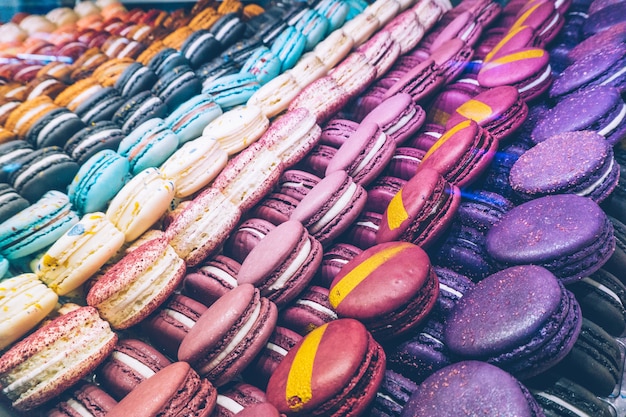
[107,362,217,417]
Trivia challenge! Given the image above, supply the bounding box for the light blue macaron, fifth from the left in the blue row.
[202,72,261,110]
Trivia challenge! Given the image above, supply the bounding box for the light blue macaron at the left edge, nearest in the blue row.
[0,190,78,261]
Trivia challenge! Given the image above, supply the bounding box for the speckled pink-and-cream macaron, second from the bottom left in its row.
[87,234,186,329]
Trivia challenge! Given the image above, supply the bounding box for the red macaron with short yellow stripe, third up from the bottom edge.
[376,168,461,247]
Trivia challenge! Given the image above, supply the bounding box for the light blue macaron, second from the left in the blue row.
[67,149,130,215]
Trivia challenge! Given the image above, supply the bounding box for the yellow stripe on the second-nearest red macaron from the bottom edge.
[328,242,413,308]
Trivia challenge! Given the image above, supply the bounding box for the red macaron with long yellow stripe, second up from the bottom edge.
[329,242,439,340]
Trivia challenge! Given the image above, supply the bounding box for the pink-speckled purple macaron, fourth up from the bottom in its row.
[509,131,619,204]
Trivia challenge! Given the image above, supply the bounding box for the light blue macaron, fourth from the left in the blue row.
[165,94,222,147]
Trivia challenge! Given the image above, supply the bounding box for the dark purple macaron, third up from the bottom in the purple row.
[486,194,615,283]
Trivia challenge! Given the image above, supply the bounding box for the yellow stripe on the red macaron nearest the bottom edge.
[285,324,328,411]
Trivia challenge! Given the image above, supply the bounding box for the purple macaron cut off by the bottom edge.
[400,361,544,417]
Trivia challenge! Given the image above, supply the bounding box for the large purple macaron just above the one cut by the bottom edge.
[444,265,582,379]
